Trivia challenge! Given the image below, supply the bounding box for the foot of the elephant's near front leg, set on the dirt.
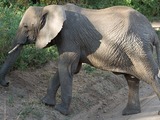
[55,104,69,115]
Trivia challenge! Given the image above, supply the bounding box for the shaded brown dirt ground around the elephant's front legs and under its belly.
[0,62,159,120]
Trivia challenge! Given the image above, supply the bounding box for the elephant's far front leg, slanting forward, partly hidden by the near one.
[42,71,60,106]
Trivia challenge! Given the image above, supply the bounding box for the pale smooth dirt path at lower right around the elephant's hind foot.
[71,83,160,120]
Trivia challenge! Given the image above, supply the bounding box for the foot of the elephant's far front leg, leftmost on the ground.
[42,95,56,106]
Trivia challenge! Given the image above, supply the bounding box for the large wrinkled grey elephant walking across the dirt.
[0,4,160,115]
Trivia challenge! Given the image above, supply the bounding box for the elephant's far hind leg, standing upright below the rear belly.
[122,75,141,115]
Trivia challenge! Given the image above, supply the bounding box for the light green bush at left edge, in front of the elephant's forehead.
[0,6,22,64]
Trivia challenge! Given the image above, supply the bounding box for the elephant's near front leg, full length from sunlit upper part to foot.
[55,53,79,115]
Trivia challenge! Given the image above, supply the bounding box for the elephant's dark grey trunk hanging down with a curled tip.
[0,45,23,87]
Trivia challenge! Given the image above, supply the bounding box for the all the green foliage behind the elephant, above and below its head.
[0,0,160,69]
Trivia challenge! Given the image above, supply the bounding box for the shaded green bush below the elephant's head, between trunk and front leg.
[14,45,58,70]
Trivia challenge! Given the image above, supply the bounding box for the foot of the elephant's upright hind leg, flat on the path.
[122,106,141,115]
